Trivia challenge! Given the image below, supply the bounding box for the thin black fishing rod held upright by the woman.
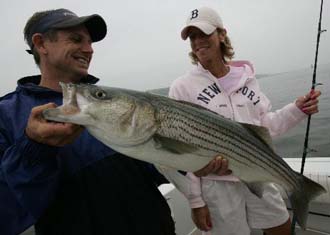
[291,0,326,235]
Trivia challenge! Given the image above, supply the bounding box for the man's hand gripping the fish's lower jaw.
[25,103,84,146]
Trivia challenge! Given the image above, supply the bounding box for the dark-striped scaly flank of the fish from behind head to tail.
[152,99,298,187]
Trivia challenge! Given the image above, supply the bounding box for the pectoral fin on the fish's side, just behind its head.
[153,135,198,154]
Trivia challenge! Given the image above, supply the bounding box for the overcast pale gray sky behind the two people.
[0,0,330,96]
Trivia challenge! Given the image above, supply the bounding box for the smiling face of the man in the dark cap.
[45,26,93,79]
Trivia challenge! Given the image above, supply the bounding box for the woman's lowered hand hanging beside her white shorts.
[191,205,212,231]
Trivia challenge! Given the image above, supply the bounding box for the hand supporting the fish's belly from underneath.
[194,156,232,177]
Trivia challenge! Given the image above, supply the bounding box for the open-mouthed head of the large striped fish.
[43,83,157,146]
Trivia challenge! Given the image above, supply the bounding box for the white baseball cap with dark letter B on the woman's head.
[181,7,223,40]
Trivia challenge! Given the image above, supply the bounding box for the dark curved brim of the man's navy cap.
[52,14,107,42]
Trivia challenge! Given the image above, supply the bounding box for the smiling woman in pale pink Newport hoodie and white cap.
[169,7,320,235]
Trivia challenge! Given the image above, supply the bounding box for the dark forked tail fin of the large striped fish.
[289,173,326,230]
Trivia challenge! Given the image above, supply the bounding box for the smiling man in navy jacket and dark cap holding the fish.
[0,9,226,235]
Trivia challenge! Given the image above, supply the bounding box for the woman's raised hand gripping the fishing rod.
[296,90,321,115]
